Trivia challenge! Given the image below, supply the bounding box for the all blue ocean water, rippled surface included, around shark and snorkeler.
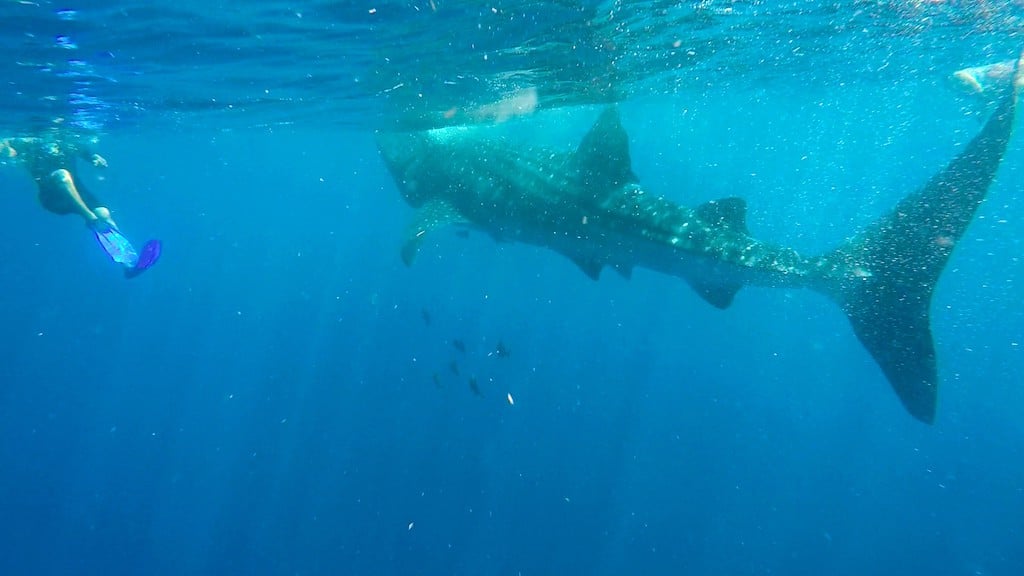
[0,0,1024,575]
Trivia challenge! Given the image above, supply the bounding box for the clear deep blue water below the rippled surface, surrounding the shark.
[0,86,1024,575]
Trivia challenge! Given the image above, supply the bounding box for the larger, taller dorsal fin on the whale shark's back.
[572,108,637,199]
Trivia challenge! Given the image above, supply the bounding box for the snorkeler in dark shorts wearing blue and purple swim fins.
[0,137,161,278]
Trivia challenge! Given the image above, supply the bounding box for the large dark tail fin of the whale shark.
[822,55,1024,423]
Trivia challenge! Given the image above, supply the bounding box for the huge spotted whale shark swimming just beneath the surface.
[377,65,1021,423]
